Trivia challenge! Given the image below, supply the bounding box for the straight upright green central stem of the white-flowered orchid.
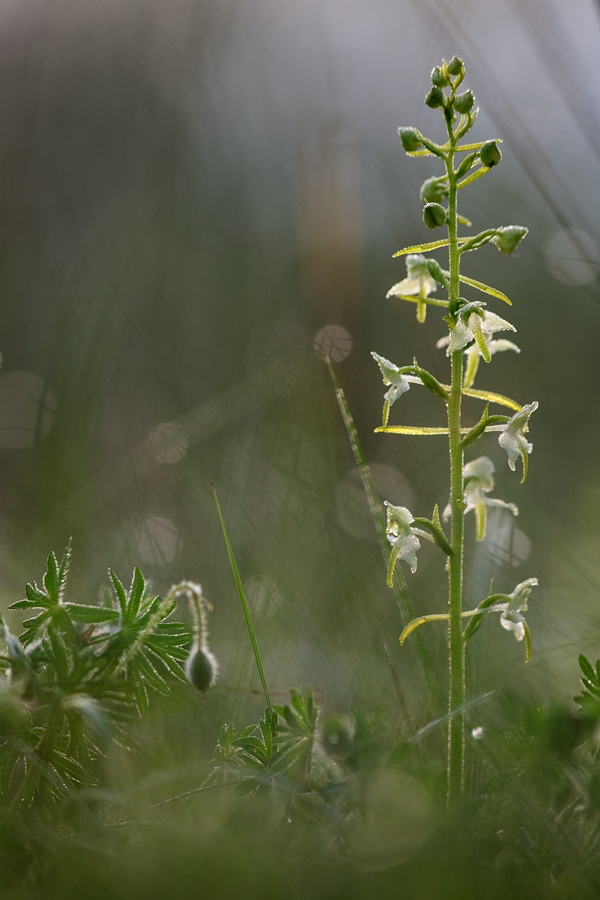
[446,123,465,805]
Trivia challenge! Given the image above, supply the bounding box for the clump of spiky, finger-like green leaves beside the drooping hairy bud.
[0,543,190,819]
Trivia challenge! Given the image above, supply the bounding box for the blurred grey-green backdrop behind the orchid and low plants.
[0,0,600,744]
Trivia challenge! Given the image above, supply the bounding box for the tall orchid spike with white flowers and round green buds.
[373,56,538,803]
